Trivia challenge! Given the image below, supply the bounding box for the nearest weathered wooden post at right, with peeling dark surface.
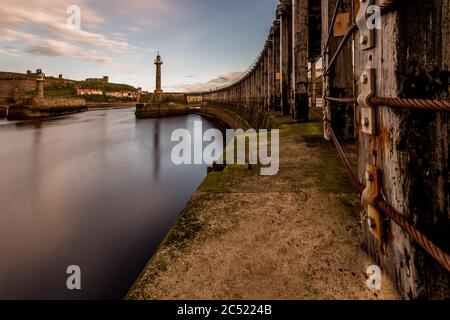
[355,0,450,299]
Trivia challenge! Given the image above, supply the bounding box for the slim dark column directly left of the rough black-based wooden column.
[277,0,292,115]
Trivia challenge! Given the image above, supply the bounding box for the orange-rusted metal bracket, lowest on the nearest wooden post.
[361,164,383,245]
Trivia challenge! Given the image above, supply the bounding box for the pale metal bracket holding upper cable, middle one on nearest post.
[357,69,376,135]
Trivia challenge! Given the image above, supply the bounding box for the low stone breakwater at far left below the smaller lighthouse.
[8,98,87,120]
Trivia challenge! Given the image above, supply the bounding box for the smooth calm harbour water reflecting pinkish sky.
[0,109,214,299]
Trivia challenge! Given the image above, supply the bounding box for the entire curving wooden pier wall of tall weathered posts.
[138,0,450,299]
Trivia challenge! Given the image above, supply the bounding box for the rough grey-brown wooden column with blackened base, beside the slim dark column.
[292,0,309,122]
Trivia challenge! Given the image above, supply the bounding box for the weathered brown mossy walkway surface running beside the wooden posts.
[127,115,399,300]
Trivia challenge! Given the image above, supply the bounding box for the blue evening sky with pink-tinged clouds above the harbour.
[0,0,279,92]
